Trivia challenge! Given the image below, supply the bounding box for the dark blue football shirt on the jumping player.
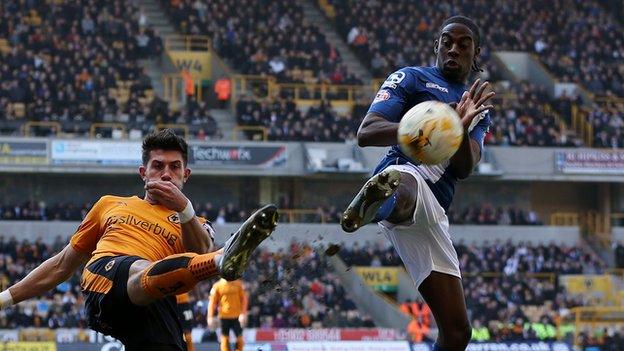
[368,66,492,211]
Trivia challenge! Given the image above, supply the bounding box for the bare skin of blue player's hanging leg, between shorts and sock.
[418,271,470,337]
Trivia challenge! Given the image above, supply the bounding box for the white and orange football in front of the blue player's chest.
[398,101,464,165]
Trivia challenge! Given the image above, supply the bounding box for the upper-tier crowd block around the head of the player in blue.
[326,0,624,96]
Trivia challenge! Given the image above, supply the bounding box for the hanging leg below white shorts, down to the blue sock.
[418,272,472,351]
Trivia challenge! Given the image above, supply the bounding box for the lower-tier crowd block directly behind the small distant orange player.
[193,243,374,328]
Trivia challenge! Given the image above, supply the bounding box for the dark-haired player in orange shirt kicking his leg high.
[0,129,277,351]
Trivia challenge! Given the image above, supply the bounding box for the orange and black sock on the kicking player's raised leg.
[141,252,220,299]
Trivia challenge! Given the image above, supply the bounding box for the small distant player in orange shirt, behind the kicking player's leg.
[208,279,247,351]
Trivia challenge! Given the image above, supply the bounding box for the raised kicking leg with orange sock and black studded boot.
[128,205,278,305]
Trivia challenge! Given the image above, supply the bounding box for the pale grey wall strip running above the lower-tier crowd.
[0,221,580,250]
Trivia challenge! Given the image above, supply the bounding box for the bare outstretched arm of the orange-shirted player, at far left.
[9,245,90,303]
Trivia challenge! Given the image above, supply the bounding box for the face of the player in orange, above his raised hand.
[139,150,191,189]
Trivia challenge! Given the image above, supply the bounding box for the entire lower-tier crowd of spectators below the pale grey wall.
[0,236,618,344]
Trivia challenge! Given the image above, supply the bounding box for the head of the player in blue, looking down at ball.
[435,23,480,82]
